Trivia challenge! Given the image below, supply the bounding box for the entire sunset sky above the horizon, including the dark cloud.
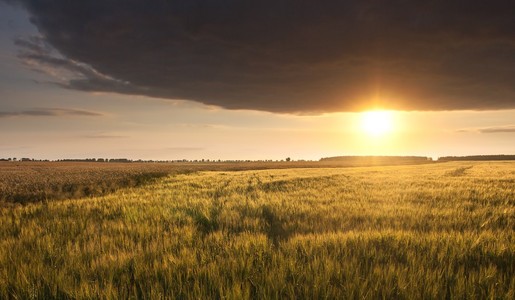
[0,0,515,160]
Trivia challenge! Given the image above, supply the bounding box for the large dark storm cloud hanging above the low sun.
[4,0,515,113]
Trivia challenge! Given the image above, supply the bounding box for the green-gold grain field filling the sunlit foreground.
[0,162,515,299]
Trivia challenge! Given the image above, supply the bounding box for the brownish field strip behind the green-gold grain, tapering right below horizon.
[0,161,436,205]
